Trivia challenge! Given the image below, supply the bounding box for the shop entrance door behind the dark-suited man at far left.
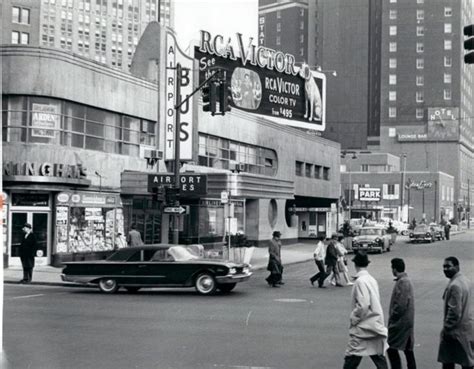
[10,211,49,265]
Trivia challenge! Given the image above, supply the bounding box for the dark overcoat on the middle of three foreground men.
[388,273,415,351]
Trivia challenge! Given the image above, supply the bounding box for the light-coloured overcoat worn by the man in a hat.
[346,269,387,356]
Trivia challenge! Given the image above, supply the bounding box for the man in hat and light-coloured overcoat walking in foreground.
[343,252,388,369]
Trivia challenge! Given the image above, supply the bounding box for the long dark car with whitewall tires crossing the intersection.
[61,244,252,295]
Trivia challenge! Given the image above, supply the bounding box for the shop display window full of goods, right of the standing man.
[56,192,126,253]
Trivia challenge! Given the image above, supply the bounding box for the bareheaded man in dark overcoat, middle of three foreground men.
[387,258,416,369]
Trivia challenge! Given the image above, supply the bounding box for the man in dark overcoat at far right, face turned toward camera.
[438,256,474,369]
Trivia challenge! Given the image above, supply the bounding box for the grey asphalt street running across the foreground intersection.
[4,231,474,369]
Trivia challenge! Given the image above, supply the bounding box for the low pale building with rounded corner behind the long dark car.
[0,46,340,265]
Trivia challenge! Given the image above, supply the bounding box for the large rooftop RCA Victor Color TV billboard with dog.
[194,31,326,131]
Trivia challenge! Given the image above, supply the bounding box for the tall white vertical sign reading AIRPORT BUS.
[164,30,194,160]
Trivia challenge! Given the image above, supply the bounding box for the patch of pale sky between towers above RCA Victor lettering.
[175,0,258,51]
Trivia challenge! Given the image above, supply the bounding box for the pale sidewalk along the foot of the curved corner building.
[3,242,314,286]
